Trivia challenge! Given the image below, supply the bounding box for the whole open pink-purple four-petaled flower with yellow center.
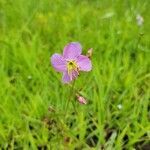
[51,42,92,83]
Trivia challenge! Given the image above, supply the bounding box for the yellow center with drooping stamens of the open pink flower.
[67,60,79,76]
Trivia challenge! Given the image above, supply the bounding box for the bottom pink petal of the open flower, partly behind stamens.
[62,71,78,83]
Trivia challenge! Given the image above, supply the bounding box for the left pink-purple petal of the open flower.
[51,54,67,72]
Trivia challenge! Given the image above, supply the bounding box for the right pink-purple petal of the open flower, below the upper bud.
[77,55,92,71]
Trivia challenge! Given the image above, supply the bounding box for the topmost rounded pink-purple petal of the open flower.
[63,42,82,59]
